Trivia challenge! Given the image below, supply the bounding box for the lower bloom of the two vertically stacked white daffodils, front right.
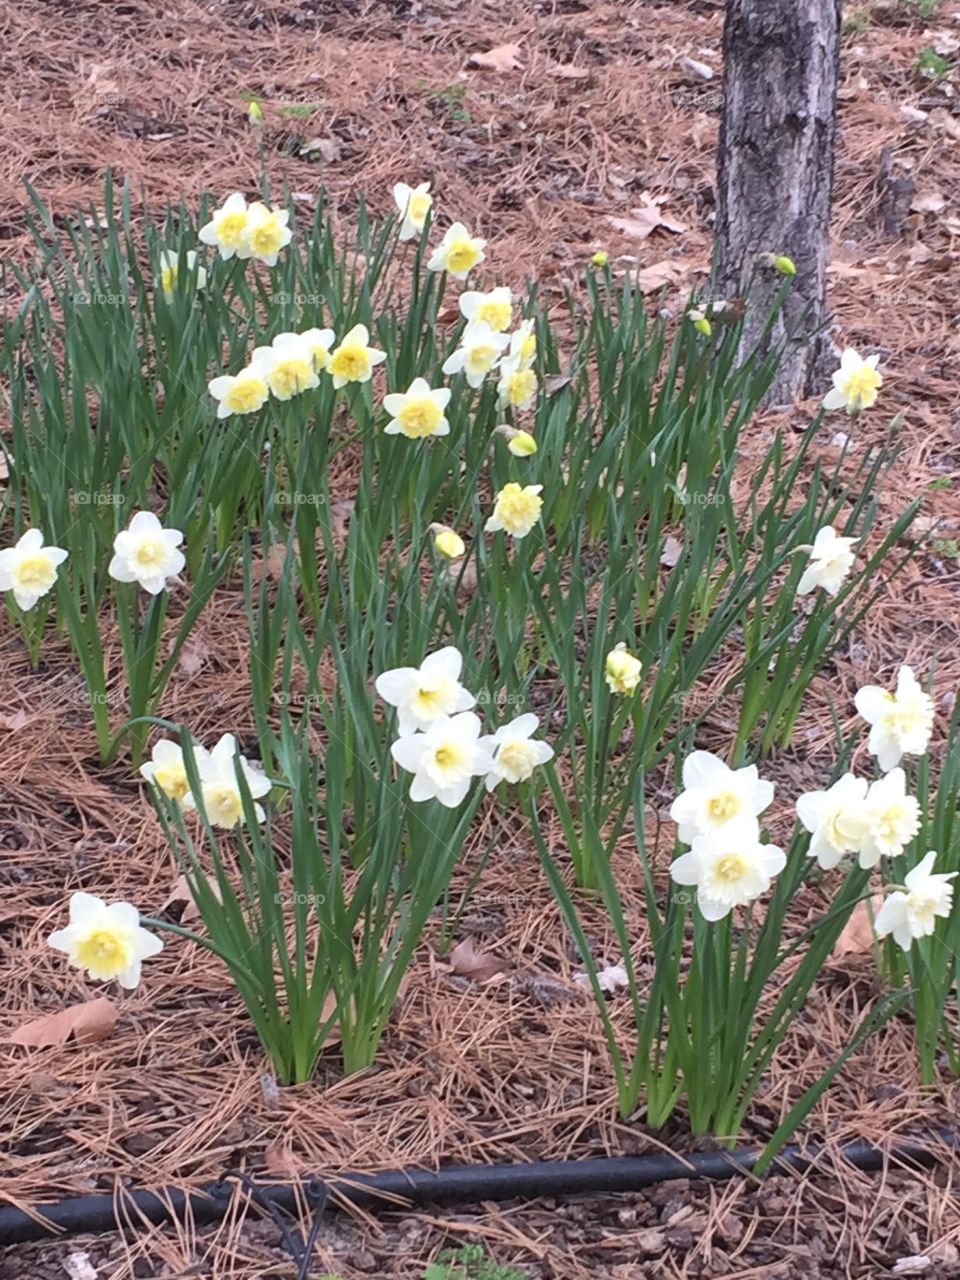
[669,823,787,920]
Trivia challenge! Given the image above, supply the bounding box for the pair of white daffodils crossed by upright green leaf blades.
[140,733,271,831]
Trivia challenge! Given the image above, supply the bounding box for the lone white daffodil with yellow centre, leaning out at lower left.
[47,893,164,991]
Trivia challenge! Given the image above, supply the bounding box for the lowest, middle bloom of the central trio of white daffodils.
[390,712,493,809]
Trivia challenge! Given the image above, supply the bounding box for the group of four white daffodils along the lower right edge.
[796,667,956,948]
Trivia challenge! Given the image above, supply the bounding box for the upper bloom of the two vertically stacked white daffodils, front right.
[669,751,773,844]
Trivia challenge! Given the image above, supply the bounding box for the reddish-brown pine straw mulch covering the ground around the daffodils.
[0,0,960,1280]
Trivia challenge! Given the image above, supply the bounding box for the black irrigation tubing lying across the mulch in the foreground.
[0,1133,956,1245]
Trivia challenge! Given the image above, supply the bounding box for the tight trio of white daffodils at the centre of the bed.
[376,645,553,809]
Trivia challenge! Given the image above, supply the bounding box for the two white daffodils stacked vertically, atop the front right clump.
[669,751,786,920]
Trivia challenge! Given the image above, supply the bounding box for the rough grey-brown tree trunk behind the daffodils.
[714,0,841,404]
